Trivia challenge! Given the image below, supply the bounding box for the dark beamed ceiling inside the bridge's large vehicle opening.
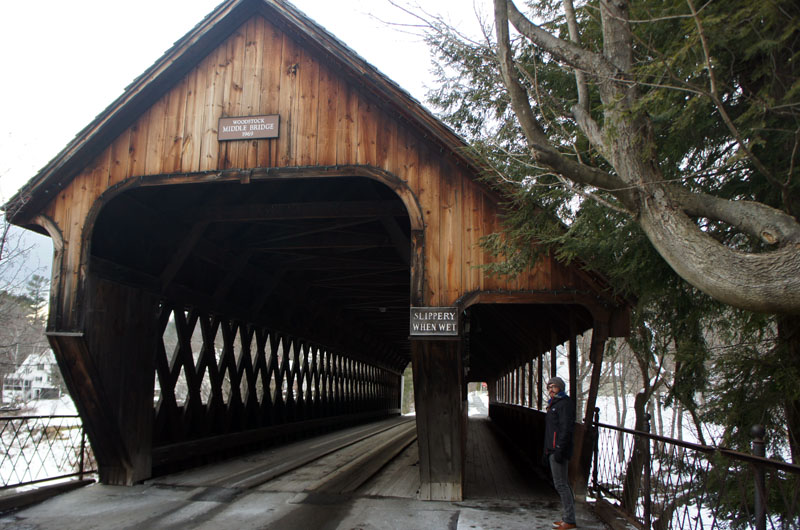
[90,177,410,371]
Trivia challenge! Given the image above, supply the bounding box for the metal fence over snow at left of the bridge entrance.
[0,416,97,489]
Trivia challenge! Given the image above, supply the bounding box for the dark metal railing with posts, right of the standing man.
[590,415,800,530]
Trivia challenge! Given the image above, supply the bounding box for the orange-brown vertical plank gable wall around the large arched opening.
[45,16,592,329]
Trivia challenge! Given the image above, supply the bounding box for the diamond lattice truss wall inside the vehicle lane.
[154,303,400,445]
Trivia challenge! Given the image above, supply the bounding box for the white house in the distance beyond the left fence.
[3,350,61,403]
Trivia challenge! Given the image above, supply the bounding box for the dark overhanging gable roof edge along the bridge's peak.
[3,0,479,225]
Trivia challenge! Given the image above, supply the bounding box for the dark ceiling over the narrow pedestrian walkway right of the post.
[466,304,593,381]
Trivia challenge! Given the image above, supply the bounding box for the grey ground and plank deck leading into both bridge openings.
[0,417,605,530]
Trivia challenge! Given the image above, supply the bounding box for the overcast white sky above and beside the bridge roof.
[0,0,491,274]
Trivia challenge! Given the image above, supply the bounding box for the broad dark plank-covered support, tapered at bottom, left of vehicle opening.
[47,278,156,485]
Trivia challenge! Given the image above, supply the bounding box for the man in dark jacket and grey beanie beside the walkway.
[544,377,577,530]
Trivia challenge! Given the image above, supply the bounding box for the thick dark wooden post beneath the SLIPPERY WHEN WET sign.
[411,340,466,501]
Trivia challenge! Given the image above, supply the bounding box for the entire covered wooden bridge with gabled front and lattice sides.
[6,0,627,499]
